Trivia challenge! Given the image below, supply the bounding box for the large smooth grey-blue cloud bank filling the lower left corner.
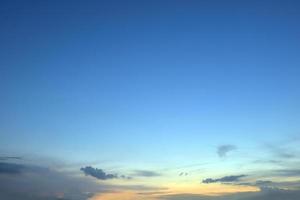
[0,163,106,200]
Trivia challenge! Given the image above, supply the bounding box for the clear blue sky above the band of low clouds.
[0,1,300,163]
